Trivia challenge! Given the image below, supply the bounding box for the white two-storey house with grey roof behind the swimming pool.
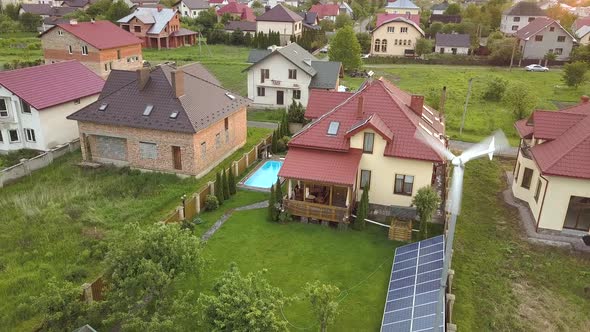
[246,43,342,107]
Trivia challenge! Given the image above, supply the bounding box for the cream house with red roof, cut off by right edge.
[512,97,590,233]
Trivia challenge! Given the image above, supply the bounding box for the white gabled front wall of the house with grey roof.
[248,53,312,107]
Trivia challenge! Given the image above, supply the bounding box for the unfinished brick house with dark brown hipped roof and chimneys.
[68,64,249,177]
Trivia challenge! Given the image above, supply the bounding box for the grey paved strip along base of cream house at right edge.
[502,172,590,253]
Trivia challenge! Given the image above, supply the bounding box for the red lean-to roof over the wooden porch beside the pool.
[279,148,363,186]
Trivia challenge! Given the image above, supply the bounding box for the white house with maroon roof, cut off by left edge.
[0,61,104,152]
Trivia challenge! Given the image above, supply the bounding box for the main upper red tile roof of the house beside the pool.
[289,79,444,162]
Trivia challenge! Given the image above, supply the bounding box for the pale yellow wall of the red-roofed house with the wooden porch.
[350,129,433,206]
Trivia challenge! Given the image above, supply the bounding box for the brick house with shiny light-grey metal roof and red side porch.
[117,5,197,49]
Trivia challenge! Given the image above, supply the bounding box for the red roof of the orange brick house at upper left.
[41,21,141,50]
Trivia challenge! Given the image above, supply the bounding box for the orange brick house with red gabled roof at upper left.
[41,20,143,78]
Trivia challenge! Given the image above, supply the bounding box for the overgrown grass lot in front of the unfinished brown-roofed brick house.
[0,129,269,331]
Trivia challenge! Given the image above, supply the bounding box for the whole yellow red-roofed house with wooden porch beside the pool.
[279,79,445,222]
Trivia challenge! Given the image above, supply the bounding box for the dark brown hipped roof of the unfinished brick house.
[68,65,249,133]
